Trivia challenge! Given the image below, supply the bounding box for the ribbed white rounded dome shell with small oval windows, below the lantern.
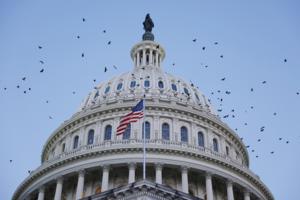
[79,41,216,115]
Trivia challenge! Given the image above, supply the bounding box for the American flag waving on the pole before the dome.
[117,99,144,135]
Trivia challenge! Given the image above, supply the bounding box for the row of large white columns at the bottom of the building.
[38,163,250,200]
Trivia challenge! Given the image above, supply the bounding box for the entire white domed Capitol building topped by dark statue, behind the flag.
[12,15,274,200]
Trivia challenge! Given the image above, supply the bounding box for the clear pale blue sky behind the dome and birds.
[0,0,300,200]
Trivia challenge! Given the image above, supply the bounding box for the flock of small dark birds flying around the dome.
[3,18,300,170]
